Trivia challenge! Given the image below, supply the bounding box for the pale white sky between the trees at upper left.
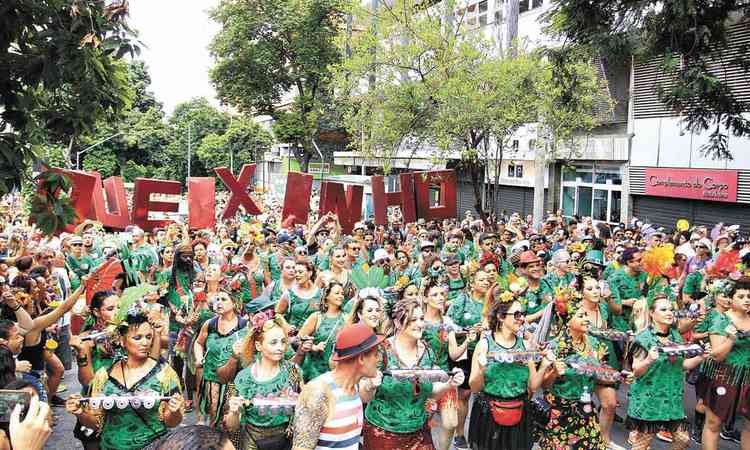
[130,0,219,114]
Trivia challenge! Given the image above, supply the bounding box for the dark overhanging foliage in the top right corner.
[548,0,750,159]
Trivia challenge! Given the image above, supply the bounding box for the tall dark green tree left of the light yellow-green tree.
[211,0,347,171]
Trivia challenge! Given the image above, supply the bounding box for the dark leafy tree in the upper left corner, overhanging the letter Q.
[0,0,137,233]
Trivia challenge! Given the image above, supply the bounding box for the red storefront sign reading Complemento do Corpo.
[646,168,737,203]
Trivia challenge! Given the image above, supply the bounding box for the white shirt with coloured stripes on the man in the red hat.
[315,372,363,450]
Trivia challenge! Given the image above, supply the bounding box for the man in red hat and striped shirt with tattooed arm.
[292,323,385,450]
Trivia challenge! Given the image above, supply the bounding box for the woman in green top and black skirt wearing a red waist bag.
[469,294,551,450]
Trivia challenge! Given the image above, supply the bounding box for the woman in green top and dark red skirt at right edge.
[696,277,750,450]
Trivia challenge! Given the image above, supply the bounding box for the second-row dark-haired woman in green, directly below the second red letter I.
[276,259,320,330]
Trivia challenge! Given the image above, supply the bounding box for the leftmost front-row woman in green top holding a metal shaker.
[66,305,184,450]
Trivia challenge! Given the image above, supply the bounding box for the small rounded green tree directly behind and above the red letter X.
[196,117,273,172]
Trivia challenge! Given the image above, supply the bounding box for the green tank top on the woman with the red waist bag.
[484,336,529,398]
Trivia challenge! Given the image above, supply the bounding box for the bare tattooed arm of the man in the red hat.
[292,382,331,450]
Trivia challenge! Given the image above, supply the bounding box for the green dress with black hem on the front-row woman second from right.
[628,328,685,433]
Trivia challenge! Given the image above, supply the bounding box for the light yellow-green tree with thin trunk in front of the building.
[335,0,600,219]
